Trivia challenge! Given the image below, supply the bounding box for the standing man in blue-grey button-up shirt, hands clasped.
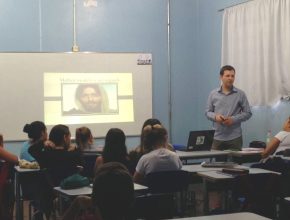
[206,65,252,150]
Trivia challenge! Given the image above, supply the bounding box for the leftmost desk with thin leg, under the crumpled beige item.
[15,166,40,220]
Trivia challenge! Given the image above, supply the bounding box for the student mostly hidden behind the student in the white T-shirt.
[129,118,174,172]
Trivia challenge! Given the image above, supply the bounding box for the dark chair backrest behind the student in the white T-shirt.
[145,170,190,193]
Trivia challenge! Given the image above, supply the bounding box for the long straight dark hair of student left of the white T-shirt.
[102,128,128,163]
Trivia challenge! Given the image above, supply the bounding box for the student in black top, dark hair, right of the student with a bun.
[28,124,83,186]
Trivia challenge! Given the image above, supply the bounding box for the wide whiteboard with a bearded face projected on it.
[0,52,152,141]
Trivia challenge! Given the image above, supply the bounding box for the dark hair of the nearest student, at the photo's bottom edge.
[92,162,134,220]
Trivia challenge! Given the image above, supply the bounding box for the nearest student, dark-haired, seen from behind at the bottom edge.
[63,162,134,220]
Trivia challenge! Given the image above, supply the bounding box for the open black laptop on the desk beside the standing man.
[186,130,214,151]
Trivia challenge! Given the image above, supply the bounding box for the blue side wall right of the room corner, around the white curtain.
[196,0,290,146]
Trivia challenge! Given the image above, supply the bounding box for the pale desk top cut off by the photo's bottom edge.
[167,212,269,220]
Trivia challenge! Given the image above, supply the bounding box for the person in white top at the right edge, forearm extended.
[262,117,290,158]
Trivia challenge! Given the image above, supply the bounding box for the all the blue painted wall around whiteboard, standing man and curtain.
[0,0,290,156]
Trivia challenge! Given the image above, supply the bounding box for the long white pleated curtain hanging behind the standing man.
[221,0,290,106]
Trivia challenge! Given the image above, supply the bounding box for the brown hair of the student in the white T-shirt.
[143,125,167,150]
